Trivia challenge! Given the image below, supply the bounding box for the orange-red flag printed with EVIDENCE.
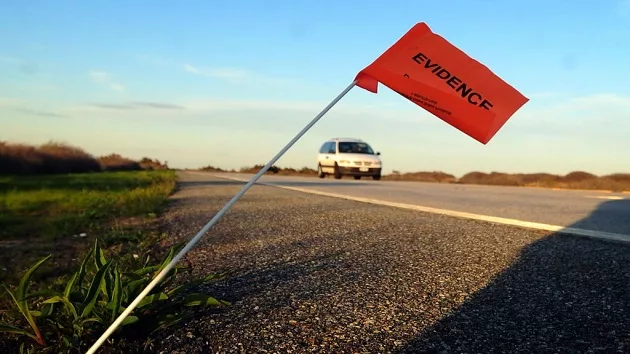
[355,22,529,144]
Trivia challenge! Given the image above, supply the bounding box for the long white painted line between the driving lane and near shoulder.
[201,174,630,243]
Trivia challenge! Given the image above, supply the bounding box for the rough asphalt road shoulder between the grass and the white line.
[153,173,630,353]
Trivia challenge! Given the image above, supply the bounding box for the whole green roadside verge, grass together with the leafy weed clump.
[0,170,229,353]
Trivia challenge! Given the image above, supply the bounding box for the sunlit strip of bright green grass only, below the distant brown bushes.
[0,171,175,240]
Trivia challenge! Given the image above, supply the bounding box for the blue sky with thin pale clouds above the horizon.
[0,0,630,175]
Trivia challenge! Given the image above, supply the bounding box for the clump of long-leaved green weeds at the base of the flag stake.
[0,241,230,353]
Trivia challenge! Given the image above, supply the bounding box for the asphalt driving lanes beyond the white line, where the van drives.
[213,173,630,235]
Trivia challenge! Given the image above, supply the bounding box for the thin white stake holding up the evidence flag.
[87,80,357,354]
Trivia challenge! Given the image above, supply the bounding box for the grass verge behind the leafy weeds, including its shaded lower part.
[0,170,177,288]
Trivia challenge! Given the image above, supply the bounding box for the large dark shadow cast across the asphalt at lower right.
[401,200,630,353]
